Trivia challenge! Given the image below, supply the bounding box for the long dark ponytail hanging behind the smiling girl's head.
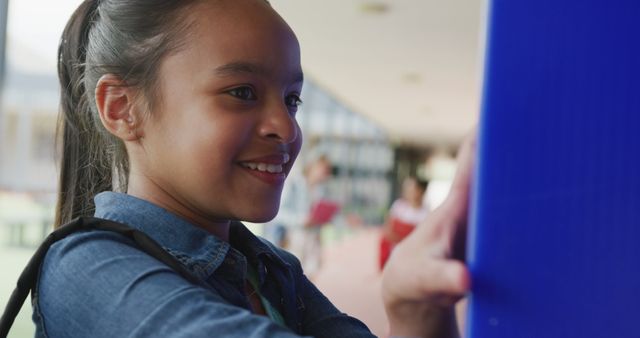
[54,0,112,227]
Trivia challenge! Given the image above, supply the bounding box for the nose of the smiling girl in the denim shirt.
[259,102,298,144]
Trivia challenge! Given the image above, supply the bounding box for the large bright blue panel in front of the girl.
[466,0,640,338]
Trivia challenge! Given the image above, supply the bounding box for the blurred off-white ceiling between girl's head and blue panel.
[270,0,485,146]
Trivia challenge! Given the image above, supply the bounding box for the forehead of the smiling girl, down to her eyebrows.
[162,0,302,84]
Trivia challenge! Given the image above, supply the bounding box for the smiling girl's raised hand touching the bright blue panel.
[382,132,476,338]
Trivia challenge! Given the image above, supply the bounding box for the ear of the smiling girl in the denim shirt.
[95,74,142,141]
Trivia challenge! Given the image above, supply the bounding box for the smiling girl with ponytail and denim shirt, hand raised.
[34,0,468,337]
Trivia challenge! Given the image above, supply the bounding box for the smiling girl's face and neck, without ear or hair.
[129,0,302,227]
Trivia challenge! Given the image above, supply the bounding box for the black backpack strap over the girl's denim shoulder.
[0,217,204,337]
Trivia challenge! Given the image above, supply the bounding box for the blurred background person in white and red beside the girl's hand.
[378,177,430,270]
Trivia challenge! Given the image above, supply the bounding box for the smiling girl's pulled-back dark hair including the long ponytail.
[54,0,196,227]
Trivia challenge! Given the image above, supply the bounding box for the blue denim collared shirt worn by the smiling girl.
[33,192,373,337]
